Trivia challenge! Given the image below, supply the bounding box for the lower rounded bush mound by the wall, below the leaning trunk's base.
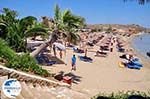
[6,54,50,77]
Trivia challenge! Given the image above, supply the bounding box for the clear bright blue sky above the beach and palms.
[0,0,150,28]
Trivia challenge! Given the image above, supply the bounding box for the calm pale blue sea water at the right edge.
[132,33,150,59]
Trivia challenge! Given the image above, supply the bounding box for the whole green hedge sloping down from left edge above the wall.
[0,39,50,77]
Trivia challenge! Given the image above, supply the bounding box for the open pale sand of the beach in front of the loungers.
[43,35,150,96]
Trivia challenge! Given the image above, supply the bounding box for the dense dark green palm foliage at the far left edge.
[0,8,47,52]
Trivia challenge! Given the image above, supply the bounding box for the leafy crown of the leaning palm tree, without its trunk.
[54,5,85,43]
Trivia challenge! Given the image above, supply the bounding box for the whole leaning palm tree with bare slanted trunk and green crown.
[30,5,85,57]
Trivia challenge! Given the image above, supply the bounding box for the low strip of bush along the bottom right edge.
[91,91,150,99]
